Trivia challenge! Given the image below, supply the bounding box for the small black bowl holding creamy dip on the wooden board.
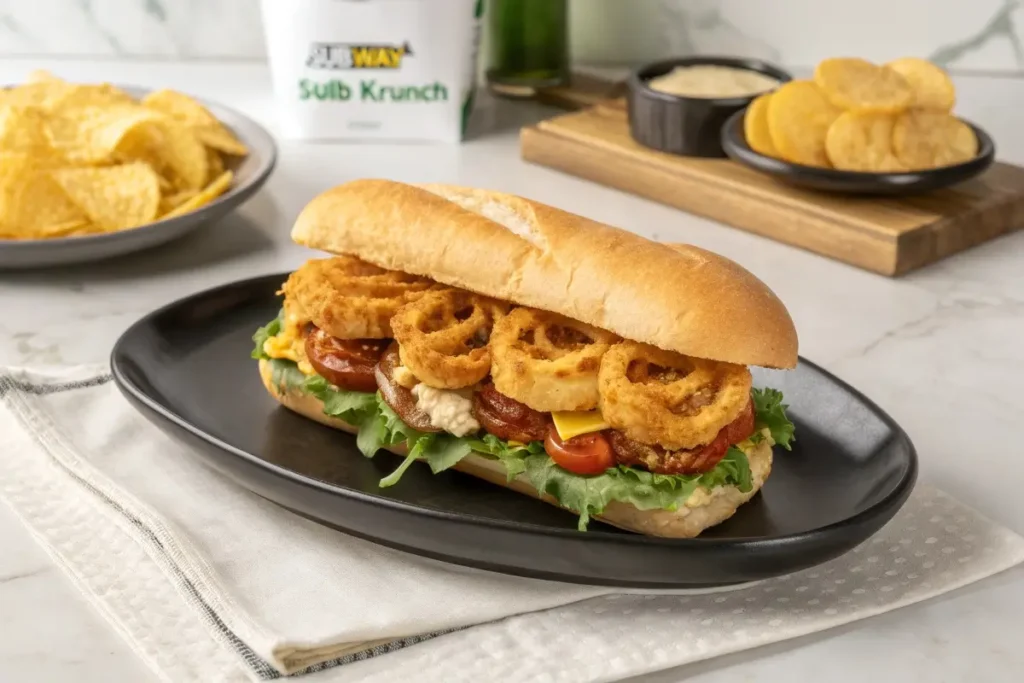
[627,56,793,158]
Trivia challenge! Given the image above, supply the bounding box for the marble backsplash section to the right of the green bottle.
[572,0,1024,73]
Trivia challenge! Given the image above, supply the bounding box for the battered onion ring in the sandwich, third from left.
[490,308,618,413]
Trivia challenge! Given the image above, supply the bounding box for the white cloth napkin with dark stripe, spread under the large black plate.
[0,367,1024,683]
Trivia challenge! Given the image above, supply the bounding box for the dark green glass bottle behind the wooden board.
[486,0,569,97]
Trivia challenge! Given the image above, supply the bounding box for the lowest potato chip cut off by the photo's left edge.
[0,154,85,237]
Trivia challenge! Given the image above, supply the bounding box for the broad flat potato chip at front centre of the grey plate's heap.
[51,164,160,231]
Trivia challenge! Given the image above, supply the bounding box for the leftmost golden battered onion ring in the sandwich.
[282,256,443,339]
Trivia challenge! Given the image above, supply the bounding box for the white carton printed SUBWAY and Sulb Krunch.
[256,0,483,142]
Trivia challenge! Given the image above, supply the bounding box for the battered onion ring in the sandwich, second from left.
[391,290,509,389]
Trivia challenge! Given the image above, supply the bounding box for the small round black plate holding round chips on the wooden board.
[722,109,995,196]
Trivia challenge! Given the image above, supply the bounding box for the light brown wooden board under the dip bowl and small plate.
[520,99,1024,275]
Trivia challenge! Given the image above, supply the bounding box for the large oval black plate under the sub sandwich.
[112,274,918,588]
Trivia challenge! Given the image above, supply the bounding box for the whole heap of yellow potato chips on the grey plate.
[0,70,240,240]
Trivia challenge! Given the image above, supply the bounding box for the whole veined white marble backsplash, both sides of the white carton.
[0,0,1024,74]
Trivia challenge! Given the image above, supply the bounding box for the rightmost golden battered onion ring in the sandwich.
[600,341,751,451]
